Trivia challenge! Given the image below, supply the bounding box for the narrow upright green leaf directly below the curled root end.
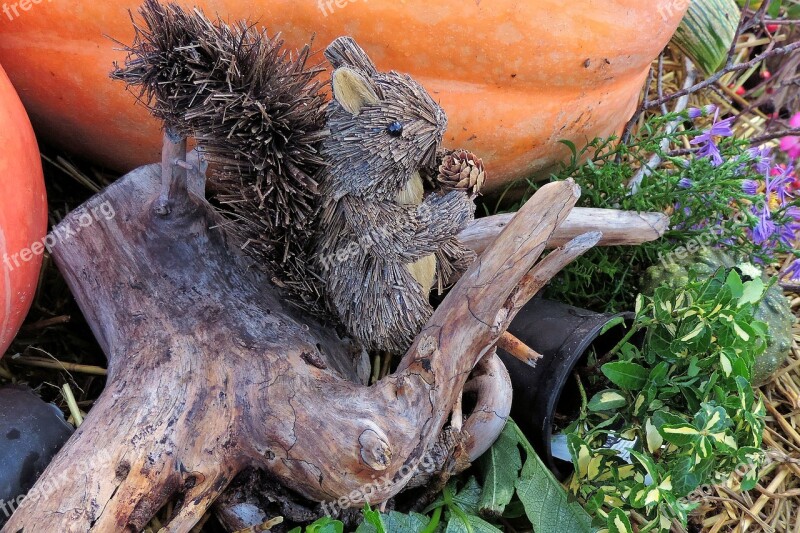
[478,425,522,515]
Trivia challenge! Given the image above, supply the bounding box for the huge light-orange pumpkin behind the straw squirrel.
[0,0,688,187]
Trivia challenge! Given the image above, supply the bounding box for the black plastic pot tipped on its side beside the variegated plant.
[498,298,632,479]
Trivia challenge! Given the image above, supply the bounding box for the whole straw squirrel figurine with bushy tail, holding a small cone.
[112,7,476,353]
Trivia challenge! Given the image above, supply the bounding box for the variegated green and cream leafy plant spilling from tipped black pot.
[567,269,768,532]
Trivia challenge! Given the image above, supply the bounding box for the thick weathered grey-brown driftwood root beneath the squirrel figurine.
[3,135,599,533]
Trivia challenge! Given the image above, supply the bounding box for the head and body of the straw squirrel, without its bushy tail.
[317,37,475,353]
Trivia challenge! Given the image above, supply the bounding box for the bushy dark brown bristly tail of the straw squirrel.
[112,0,326,310]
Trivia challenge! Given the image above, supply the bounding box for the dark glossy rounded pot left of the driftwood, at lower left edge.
[0,386,73,527]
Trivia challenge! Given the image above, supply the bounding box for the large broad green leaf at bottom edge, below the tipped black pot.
[517,448,593,533]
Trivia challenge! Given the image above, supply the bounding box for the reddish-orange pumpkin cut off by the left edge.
[0,63,47,357]
